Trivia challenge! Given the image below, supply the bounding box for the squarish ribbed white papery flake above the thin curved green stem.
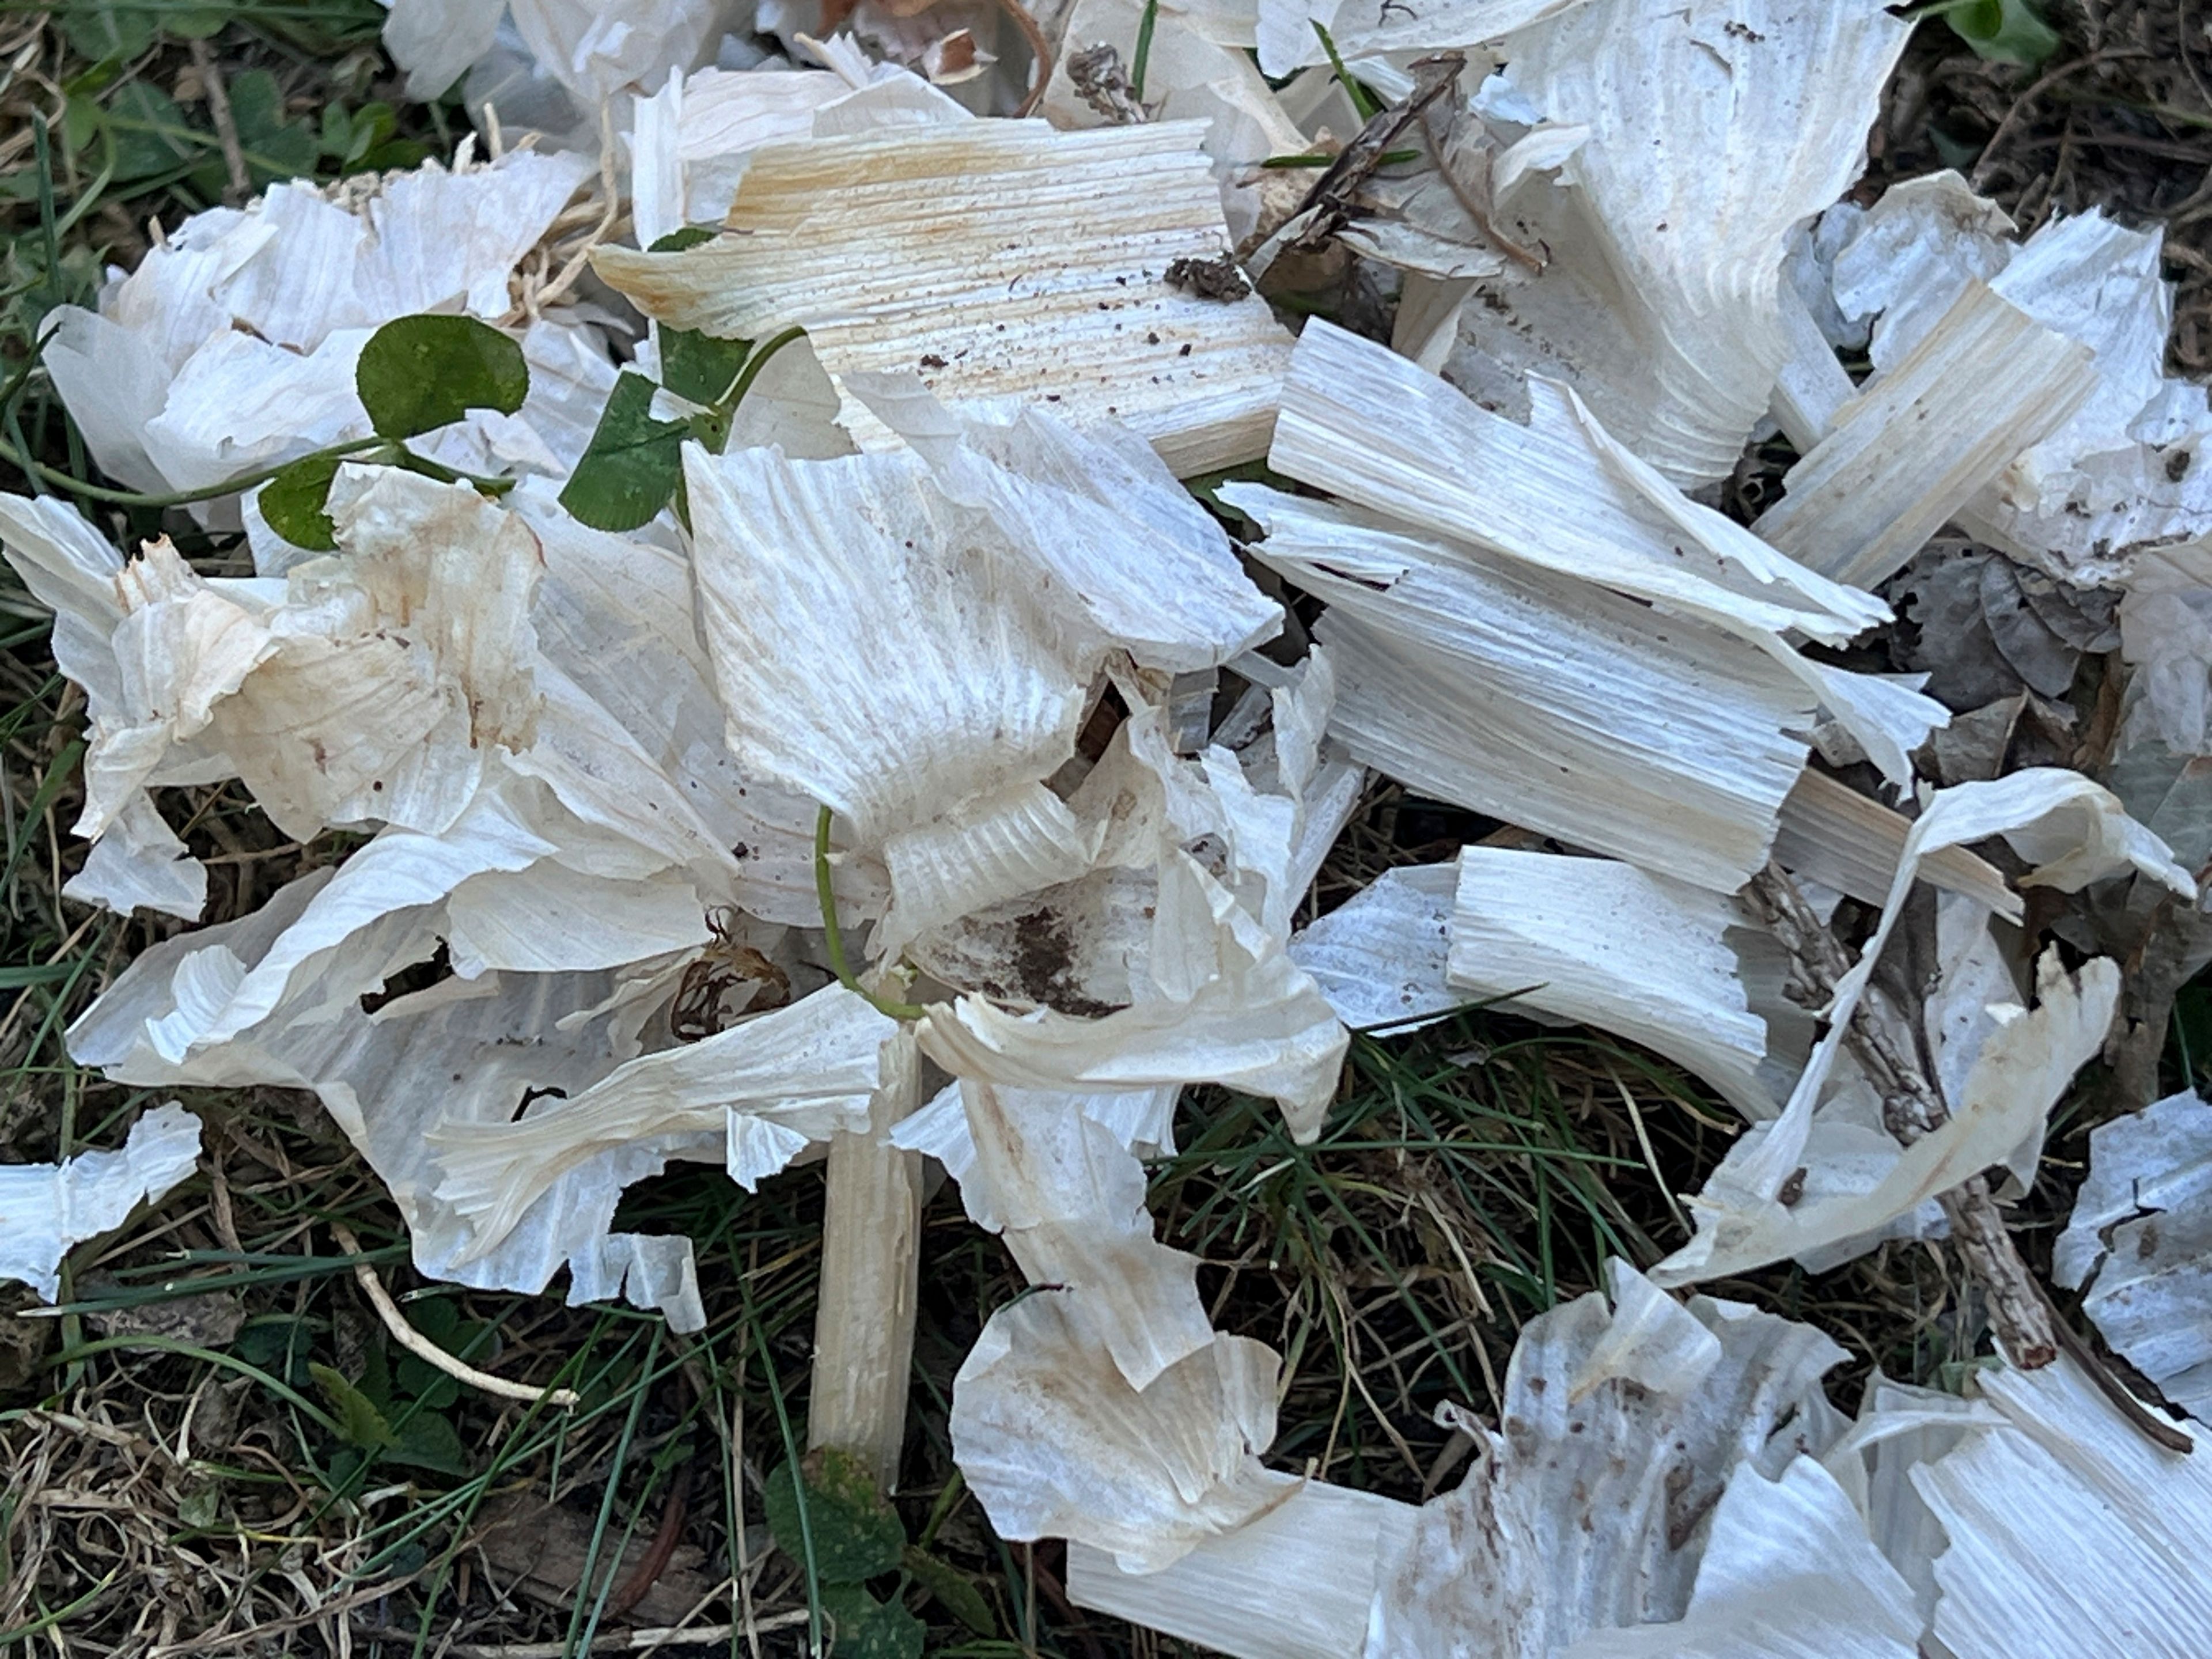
[685,447,1090,847]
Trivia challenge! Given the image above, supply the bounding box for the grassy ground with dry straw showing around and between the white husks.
[0,0,2212,1659]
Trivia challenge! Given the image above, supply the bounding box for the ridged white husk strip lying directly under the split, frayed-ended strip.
[1225,484,1814,892]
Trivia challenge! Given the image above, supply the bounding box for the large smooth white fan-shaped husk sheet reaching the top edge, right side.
[1446,0,1909,484]
